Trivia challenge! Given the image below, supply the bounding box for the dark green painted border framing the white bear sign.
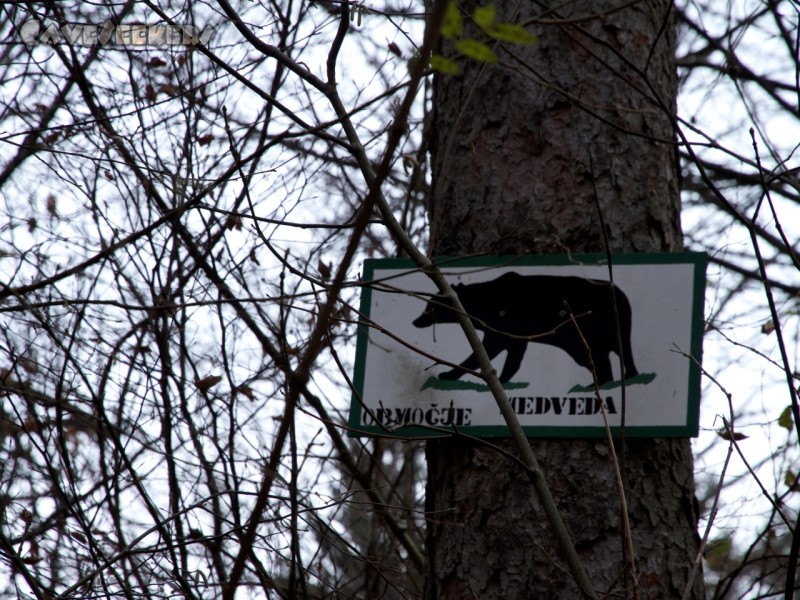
[348,252,708,439]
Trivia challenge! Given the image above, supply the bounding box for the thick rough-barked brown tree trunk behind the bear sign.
[427,1,703,600]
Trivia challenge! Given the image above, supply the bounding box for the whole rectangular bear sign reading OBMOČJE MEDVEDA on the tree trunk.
[349,253,706,438]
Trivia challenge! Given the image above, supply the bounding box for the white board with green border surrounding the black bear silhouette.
[350,253,705,437]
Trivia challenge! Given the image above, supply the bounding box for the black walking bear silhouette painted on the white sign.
[414,272,638,384]
